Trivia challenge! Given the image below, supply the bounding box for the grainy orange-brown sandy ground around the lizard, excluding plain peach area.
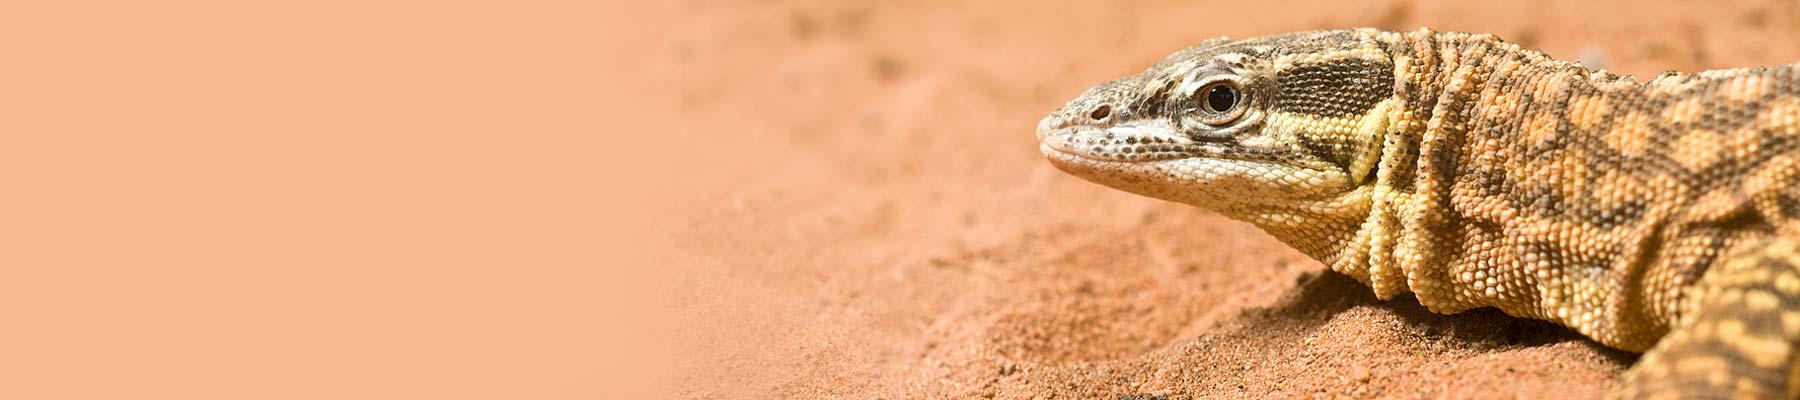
[655,0,1800,398]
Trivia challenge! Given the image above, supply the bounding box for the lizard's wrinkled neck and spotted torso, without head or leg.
[1321,31,1793,350]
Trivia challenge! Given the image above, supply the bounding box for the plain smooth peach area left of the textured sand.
[0,2,680,398]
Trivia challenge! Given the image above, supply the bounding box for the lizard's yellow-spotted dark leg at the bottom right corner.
[1613,238,1800,398]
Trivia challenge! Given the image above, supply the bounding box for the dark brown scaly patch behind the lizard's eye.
[1274,58,1393,117]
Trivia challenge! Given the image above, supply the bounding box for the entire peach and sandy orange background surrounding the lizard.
[17,0,1800,400]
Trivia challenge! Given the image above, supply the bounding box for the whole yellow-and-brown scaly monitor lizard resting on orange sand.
[1037,29,1800,398]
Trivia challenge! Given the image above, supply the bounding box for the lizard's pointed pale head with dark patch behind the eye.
[1037,31,1397,214]
